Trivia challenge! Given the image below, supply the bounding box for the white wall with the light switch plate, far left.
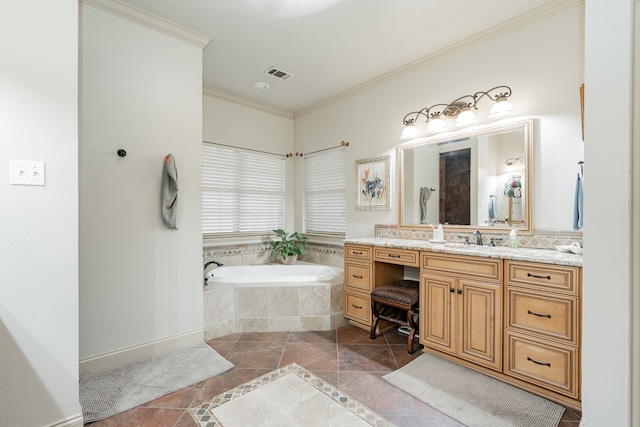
[0,0,82,427]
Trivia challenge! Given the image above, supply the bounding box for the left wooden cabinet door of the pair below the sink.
[420,274,456,354]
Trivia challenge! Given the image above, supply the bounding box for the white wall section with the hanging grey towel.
[80,5,203,360]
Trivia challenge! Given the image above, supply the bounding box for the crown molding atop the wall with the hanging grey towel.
[80,0,211,49]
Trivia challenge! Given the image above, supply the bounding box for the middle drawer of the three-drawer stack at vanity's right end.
[506,286,579,345]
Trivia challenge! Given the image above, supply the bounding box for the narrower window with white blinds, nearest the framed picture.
[304,148,347,236]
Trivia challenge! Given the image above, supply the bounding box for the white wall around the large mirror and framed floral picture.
[295,8,583,237]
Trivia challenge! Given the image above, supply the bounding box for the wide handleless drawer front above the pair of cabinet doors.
[422,252,502,282]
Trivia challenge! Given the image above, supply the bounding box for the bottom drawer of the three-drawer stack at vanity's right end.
[504,332,579,399]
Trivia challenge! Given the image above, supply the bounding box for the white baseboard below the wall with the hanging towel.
[79,329,204,376]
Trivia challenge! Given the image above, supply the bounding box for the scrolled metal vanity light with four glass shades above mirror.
[400,86,515,139]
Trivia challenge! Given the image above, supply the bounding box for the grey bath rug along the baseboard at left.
[80,343,233,423]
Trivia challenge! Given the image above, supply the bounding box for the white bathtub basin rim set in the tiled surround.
[207,263,336,285]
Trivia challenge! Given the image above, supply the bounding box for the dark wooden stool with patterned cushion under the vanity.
[371,280,420,354]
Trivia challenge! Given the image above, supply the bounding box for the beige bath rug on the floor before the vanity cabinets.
[382,353,565,427]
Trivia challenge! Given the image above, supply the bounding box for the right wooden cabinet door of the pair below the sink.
[456,279,502,371]
